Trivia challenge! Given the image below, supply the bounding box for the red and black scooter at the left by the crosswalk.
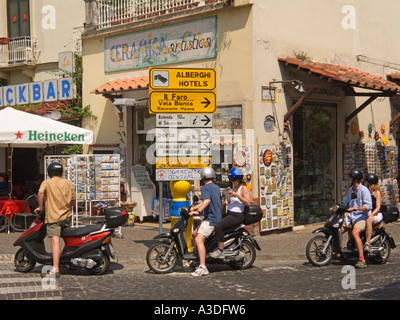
[14,207,128,275]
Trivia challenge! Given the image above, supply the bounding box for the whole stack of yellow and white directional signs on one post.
[149,67,217,181]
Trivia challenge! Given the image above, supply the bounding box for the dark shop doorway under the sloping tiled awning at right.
[293,104,336,225]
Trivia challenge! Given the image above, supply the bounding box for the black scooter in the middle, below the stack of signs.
[146,205,263,274]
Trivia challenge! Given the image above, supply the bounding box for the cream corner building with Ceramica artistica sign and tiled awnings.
[82,0,400,231]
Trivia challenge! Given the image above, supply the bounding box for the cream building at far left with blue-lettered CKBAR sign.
[0,0,85,186]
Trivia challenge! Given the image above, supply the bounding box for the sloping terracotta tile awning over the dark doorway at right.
[278,57,400,92]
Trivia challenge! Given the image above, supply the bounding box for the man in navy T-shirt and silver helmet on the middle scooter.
[190,167,222,277]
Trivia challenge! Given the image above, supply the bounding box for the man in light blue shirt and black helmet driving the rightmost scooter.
[344,169,372,268]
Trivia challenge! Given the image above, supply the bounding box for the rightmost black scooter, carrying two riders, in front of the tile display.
[306,205,399,267]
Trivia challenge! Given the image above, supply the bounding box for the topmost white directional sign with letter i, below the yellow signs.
[156,113,212,128]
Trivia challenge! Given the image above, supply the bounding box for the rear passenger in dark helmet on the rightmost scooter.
[364,173,383,252]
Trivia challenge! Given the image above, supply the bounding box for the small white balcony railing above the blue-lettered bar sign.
[0,37,39,67]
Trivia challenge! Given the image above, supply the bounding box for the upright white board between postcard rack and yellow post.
[131,165,156,222]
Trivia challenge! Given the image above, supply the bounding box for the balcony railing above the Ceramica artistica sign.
[91,0,227,29]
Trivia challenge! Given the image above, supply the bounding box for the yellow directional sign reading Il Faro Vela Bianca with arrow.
[149,91,217,113]
